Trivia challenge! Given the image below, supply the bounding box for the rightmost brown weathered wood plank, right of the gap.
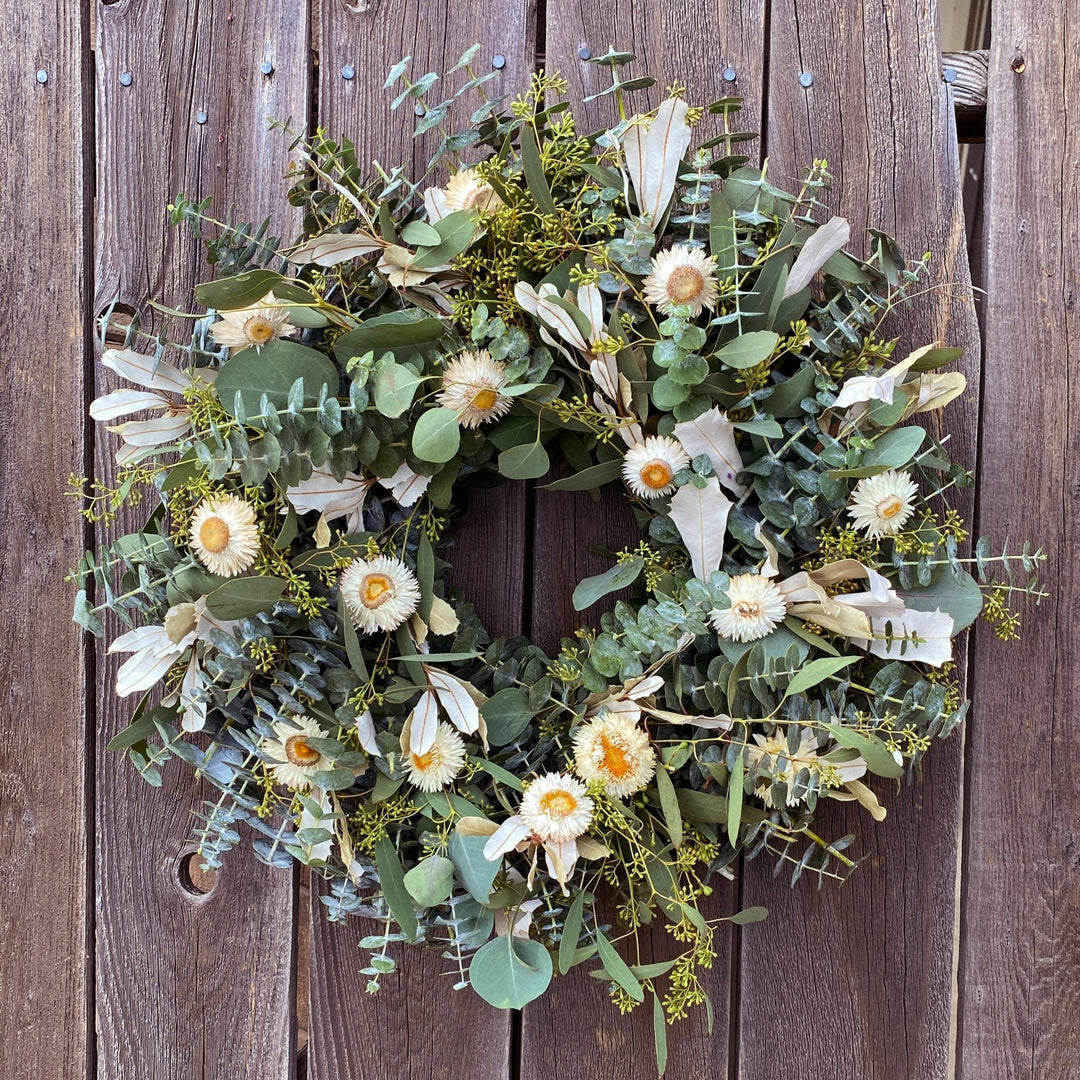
[957,0,1080,1080]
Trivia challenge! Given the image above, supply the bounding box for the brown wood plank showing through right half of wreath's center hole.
[521,0,765,1080]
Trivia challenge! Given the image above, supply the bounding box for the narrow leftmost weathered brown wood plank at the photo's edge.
[0,2,93,1080]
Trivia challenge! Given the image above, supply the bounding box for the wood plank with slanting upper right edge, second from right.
[739,0,980,1080]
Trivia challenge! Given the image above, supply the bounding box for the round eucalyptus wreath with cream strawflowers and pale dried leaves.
[76,51,1042,1063]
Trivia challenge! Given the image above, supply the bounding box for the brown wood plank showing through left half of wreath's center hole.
[309,0,535,1080]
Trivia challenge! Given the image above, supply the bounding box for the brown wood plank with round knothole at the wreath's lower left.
[95,0,310,1080]
